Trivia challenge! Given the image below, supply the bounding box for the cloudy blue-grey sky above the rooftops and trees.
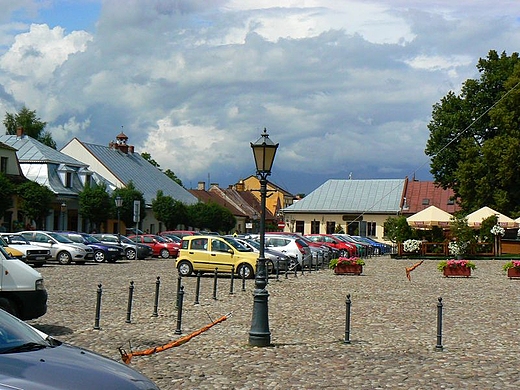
[0,0,520,194]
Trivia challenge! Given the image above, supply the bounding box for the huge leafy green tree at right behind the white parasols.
[425,50,520,214]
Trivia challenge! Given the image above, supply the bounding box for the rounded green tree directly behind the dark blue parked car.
[79,183,113,229]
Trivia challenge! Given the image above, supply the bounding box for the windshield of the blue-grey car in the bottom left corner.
[0,310,52,354]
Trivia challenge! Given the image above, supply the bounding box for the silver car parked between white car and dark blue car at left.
[19,230,94,264]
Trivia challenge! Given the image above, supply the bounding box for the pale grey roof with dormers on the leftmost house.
[0,134,87,167]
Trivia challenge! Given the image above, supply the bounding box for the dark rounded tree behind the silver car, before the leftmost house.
[16,181,55,229]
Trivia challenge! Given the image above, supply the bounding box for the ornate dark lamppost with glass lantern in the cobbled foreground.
[249,129,278,347]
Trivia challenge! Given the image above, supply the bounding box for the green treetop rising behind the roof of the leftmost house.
[4,106,56,149]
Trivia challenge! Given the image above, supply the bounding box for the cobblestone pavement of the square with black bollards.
[29,257,520,389]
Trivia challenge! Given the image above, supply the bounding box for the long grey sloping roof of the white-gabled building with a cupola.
[80,141,198,205]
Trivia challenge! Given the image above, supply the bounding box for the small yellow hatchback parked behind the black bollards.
[175,235,258,278]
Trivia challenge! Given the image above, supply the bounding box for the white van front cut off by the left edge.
[0,247,47,320]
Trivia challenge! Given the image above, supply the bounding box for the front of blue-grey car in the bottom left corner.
[0,310,159,390]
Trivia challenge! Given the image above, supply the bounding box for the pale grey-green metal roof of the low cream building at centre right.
[284,179,405,214]
